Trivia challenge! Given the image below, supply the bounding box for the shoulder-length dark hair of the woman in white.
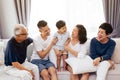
[76,24,87,44]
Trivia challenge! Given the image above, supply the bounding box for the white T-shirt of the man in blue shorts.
[31,35,51,60]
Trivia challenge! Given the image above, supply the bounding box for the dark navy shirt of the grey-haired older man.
[5,37,33,66]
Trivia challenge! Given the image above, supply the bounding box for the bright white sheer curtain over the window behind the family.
[29,0,105,38]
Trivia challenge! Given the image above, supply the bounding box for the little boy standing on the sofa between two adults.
[54,20,70,71]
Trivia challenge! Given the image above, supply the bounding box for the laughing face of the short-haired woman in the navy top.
[97,28,108,42]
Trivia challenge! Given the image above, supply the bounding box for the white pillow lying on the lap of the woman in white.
[65,56,97,74]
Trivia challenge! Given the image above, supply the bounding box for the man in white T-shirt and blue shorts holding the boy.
[31,20,58,80]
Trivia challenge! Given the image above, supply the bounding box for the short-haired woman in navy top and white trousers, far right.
[90,23,116,80]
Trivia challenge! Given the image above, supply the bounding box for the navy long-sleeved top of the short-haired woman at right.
[90,38,116,60]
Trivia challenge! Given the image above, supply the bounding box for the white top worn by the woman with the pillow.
[68,41,88,58]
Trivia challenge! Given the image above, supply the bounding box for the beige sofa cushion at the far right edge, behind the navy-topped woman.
[112,38,120,64]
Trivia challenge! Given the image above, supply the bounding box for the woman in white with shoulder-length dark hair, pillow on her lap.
[64,24,88,80]
